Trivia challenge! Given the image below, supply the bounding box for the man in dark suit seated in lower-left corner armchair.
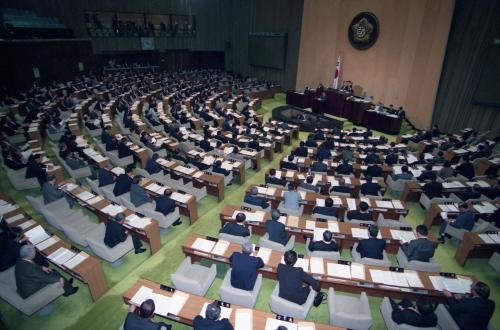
[15,244,79,299]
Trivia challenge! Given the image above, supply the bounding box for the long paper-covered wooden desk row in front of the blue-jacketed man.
[182,234,475,302]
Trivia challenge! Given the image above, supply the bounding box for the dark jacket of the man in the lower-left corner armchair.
[15,259,59,299]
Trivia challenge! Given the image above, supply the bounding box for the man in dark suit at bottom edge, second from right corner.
[389,298,437,328]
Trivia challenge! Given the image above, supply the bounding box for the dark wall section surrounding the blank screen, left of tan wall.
[225,0,303,89]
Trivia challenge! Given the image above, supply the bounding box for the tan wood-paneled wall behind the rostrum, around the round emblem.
[296,0,454,128]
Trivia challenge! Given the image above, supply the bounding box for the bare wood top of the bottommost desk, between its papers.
[123,278,343,330]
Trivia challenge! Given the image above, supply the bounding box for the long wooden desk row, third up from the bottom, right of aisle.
[219,205,437,254]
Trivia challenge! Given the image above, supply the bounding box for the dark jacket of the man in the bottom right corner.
[448,297,495,330]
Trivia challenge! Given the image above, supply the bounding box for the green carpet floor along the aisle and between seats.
[0,94,500,330]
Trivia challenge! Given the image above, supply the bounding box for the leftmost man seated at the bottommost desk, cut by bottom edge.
[123,299,172,330]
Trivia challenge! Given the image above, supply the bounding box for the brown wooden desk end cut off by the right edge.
[455,232,500,267]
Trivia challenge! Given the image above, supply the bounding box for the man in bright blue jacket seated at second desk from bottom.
[229,243,264,291]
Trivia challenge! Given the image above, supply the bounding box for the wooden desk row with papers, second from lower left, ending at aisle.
[60,181,161,254]
